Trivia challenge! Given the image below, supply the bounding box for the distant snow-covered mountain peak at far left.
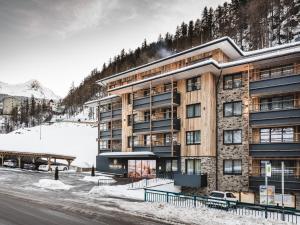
[0,80,60,100]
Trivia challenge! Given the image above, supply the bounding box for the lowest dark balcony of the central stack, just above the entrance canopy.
[133,144,180,157]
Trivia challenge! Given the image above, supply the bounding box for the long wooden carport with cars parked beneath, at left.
[0,150,76,168]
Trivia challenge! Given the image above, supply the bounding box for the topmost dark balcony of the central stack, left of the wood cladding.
[133,92,180,110]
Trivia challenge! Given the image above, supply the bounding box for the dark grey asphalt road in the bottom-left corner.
[0,193,166,225]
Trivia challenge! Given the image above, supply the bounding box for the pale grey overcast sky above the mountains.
[0,0,224,97]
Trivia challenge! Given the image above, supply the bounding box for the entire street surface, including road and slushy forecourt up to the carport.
[0,169,170,225]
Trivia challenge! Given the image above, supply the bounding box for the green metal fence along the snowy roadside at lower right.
[144,189,300,224]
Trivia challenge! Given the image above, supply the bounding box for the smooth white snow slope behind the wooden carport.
[0,122,97,167]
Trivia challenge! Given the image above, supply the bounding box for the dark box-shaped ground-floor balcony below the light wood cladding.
[174,173,207,188]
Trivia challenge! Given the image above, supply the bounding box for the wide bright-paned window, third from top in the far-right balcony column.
[259,127,294,143]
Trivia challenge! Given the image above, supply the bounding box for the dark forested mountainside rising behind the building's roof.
[63,0,300,109]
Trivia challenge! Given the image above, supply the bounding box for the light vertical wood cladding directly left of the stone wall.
[178,73,216,156]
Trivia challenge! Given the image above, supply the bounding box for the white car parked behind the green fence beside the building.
[207,191,238,209]
